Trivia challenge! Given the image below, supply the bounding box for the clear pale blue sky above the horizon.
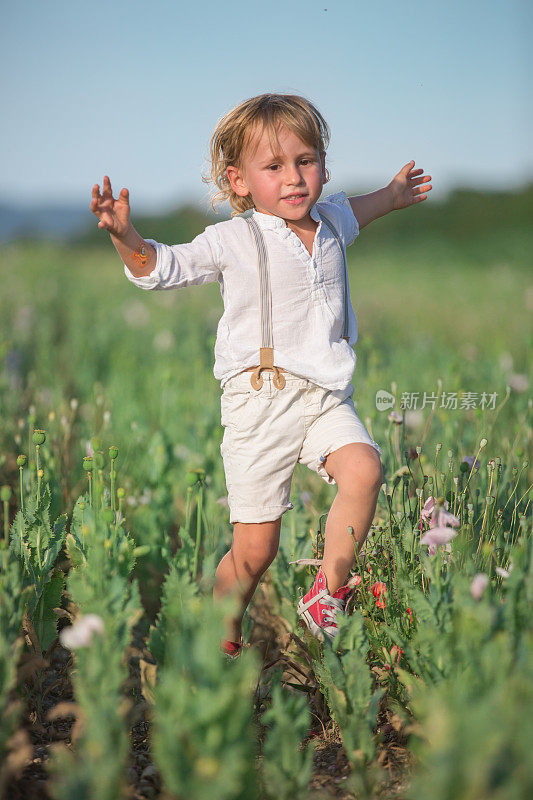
[0,0,533,213]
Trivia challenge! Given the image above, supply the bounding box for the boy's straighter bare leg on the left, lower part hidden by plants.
[213,517,281,642]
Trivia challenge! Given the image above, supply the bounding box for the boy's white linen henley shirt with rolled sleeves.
[124,192,359,389]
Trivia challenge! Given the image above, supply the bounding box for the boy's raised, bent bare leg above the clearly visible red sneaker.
[322,443,383,594]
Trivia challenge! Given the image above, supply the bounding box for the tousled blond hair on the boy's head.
[202,94,330,217]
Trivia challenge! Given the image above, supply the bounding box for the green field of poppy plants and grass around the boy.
[0,192,533,800]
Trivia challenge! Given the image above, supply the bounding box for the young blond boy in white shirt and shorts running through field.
[91,94,431,655]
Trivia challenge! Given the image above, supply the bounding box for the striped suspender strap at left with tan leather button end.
[245,217,285,391]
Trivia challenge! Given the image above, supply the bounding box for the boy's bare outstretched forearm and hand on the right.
[348,161,432,230]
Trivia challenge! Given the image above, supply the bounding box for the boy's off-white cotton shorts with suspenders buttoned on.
[220,370,381,523]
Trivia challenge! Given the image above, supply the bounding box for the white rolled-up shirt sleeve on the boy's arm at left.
[124,225,222,290]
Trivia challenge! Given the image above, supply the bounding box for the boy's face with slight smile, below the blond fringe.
[226,125,326,222]
